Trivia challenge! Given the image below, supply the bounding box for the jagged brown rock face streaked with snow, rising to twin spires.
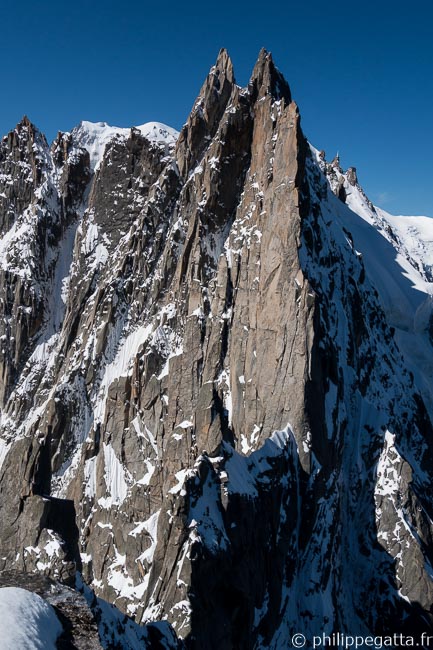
[0,50,433,650]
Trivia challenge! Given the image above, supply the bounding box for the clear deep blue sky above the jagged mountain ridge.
[0,0,433,216]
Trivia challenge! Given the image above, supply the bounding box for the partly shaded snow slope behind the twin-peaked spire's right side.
[312,148,433,417]
